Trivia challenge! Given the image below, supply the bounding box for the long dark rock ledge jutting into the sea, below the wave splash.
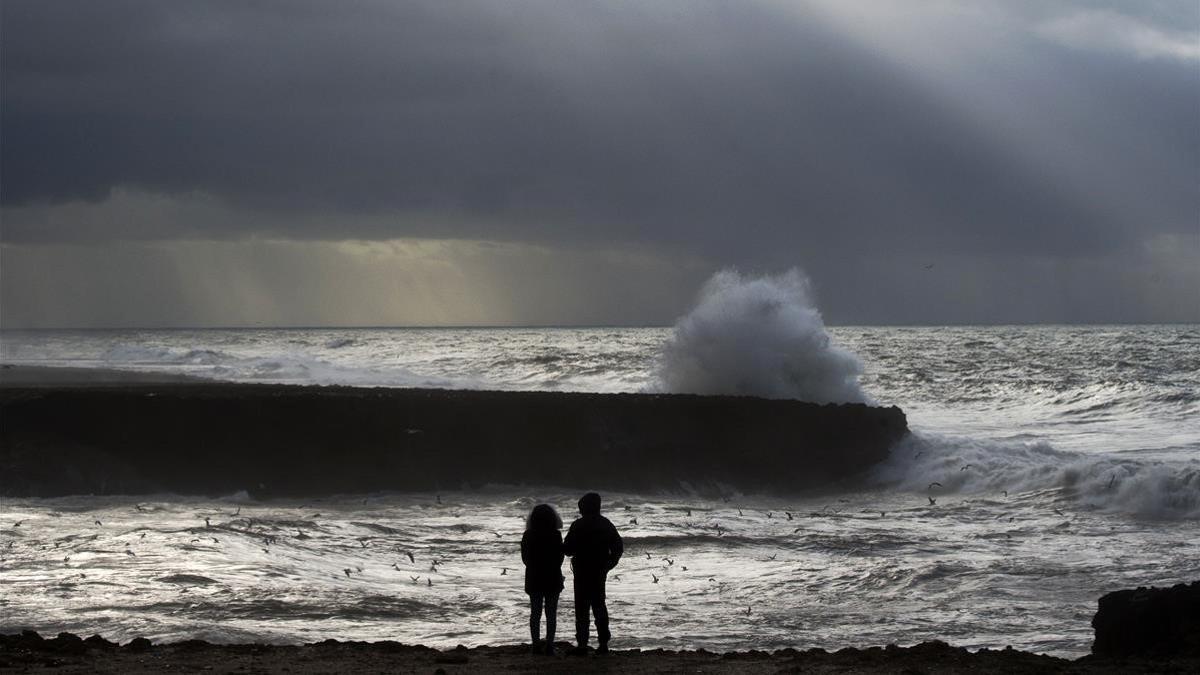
[0,383,907,497]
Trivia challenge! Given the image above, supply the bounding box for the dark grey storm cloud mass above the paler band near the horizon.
[0,0,1200,264]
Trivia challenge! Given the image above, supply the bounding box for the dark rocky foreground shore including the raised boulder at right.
[0,581,1200,674]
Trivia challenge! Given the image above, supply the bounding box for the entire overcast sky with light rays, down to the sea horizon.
[0,0,1200,328]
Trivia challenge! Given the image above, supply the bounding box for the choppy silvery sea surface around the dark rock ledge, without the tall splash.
[0,325,1200,656]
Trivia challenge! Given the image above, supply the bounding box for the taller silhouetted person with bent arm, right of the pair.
[563,492,625,653]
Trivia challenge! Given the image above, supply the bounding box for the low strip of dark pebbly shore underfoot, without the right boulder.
[0,632,1200,675]
